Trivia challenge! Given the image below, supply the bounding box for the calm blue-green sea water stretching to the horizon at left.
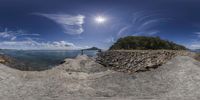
[0,50,98,69]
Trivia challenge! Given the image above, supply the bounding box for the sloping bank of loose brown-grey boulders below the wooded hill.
[97,50,195,73]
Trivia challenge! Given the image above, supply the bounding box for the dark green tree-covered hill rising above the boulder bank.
[110,36,187,50]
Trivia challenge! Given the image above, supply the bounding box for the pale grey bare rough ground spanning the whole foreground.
[0,56,200,100]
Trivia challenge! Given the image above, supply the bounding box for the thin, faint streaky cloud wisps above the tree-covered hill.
[117,12,171,37]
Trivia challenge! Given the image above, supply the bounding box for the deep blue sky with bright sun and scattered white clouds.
[0,0,200,50]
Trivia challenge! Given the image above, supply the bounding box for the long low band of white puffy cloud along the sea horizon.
[0,39,81,50]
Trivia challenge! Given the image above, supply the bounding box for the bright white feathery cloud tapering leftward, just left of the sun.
[34,13,85,35]
